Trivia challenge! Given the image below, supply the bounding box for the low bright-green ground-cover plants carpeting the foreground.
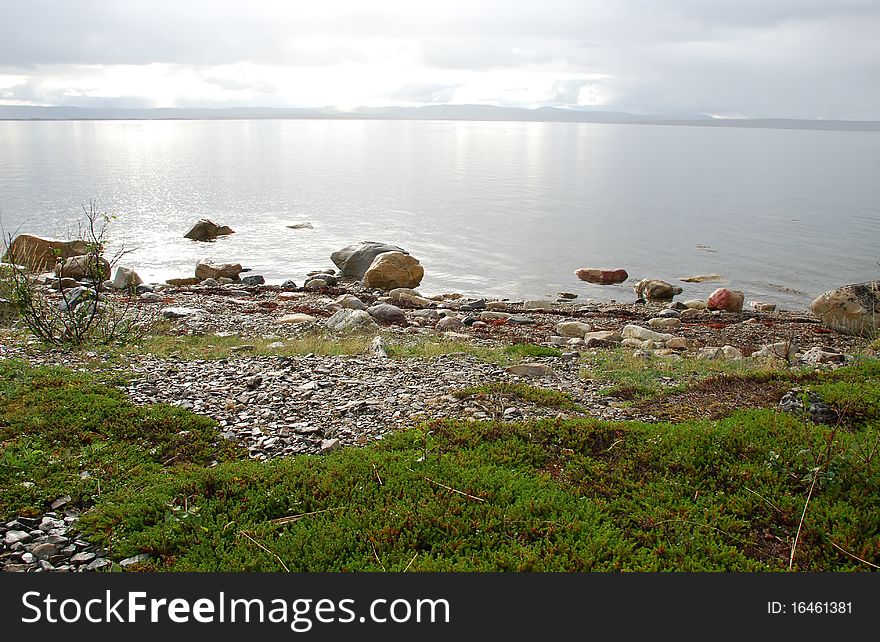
[0,359,880,571]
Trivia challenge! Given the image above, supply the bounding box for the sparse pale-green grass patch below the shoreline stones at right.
[581,348,782,401]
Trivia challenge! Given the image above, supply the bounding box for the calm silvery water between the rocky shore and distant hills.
[0,120,880,309]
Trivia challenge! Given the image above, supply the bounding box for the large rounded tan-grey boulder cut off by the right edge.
[810,281,880,338]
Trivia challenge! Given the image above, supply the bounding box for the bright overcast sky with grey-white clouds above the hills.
[0,0,880,120]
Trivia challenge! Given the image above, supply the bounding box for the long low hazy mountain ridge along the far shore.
[0,105,880,131]
